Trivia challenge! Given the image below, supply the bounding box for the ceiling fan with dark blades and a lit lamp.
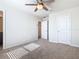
[25,0,48,12]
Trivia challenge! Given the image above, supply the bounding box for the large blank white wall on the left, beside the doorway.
[0,4,38,49]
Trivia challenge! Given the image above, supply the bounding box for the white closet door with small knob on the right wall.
[56,15,71,44]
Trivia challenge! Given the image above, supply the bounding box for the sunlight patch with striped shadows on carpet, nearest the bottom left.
[6,48,29,59]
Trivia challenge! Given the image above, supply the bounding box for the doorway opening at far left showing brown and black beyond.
[0,11,3,50]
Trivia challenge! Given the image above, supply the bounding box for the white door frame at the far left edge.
[0,9,6,49]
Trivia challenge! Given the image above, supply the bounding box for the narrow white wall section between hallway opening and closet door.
[49,13,57,42]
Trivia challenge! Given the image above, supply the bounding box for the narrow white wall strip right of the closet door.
[71,7,79,46]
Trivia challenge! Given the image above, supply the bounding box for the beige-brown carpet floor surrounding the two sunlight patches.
[0,39,79,59]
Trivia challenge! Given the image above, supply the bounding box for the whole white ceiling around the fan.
[0,0,79,17]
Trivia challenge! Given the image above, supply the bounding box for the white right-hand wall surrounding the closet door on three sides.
[49,7,79,46]
